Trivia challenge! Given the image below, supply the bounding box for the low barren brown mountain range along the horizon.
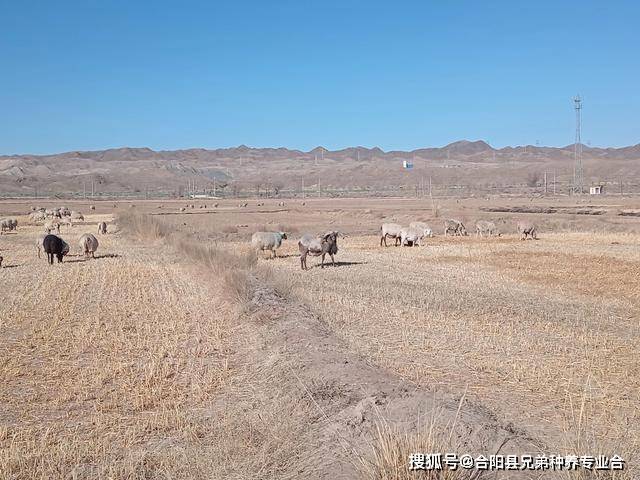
[0,140,640,195]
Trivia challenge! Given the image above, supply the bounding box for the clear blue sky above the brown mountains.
[0,0,640,154]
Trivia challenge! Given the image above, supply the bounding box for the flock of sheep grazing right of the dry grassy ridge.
[251,219,538,270]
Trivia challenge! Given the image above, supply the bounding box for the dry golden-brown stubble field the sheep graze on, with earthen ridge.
[0,198,640,479]
